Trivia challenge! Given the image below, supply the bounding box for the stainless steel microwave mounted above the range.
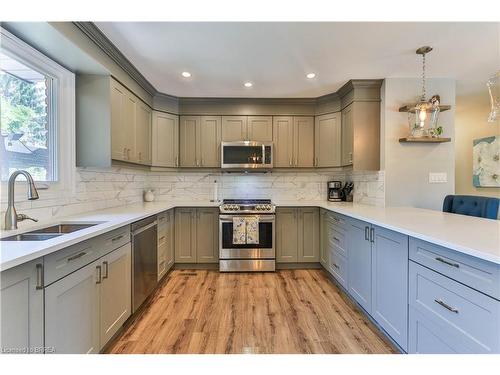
[221,141,273,169]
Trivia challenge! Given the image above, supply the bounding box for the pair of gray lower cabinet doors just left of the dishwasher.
[45,243,131,353]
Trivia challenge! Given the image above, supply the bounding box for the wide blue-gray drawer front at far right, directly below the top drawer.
[409,262,500,353]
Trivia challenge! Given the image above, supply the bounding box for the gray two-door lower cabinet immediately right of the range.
[276,207,320,263]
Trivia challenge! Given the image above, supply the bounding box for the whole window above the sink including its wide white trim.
[0,27,75,194]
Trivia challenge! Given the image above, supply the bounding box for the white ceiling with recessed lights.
[96,22,500,97]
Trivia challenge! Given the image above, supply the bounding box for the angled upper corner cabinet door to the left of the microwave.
[151,111,179,167]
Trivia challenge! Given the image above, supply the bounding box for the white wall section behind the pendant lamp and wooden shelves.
[381,78,455,210]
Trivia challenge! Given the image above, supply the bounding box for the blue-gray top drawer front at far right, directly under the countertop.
[410,238,500,300]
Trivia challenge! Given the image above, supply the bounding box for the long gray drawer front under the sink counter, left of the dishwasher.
[44,226,130,285]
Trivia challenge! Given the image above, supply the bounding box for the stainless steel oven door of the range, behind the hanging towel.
[219,215,276,259]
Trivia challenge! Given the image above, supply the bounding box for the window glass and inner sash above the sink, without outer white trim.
[0,51,57,181]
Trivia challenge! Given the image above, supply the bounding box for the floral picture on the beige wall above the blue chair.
[472,135,500,187]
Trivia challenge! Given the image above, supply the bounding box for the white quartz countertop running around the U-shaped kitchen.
[0,201,500,271]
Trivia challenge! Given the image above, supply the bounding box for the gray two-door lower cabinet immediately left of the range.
[175,207,219,263]
